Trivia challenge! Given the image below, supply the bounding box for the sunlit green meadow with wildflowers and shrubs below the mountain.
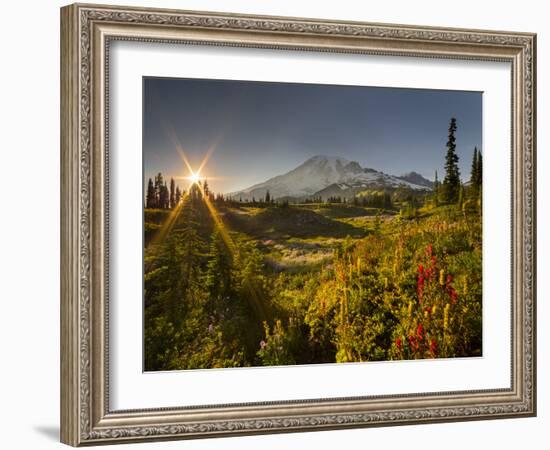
[144,183,482,371]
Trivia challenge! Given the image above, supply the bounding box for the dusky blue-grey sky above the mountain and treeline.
[143,78,482,192]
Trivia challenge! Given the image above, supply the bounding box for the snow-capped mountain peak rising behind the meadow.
[229,155,431,200]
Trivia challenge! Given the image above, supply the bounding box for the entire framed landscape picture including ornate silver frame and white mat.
[61,4,536,446]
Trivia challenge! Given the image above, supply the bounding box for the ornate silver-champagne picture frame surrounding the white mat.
[61,4,536,446]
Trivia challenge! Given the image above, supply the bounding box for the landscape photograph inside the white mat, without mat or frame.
[142,77,483,372]
